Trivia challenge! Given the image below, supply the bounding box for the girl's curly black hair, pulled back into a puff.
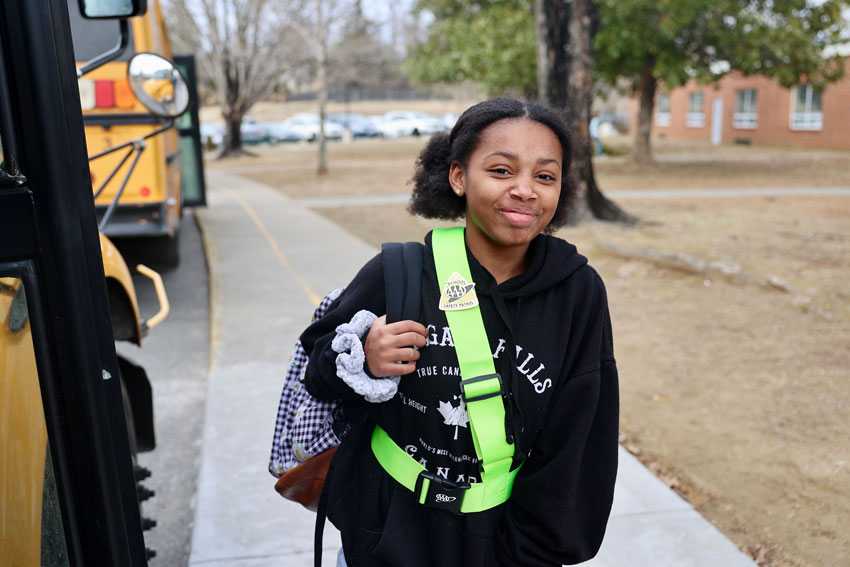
[407,98,576,232]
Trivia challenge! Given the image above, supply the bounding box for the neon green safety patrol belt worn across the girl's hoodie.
[372,227,519,513]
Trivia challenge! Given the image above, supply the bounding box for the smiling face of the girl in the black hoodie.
[449,118,563,251]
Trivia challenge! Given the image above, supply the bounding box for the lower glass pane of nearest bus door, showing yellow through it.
[0,280,69,567]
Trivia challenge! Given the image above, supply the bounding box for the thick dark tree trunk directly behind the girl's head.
[534,0,637,222]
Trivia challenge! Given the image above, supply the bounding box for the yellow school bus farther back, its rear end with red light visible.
[68,0,203,266]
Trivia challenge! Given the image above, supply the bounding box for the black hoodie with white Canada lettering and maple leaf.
[301,234,619,567]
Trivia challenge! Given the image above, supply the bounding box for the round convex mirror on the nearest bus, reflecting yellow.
[127,53,189,118]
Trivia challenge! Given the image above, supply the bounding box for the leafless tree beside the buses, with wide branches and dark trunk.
[166,0,296,157]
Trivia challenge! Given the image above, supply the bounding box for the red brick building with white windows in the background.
[632,50,850,150]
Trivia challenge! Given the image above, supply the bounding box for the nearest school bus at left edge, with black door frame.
[0,0,200,567]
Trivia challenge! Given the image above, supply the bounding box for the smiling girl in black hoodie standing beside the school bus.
[301,99,618,567]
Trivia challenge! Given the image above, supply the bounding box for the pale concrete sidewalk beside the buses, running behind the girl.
[189,171,755,567]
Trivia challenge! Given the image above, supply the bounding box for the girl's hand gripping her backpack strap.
[363,315,428,378]
